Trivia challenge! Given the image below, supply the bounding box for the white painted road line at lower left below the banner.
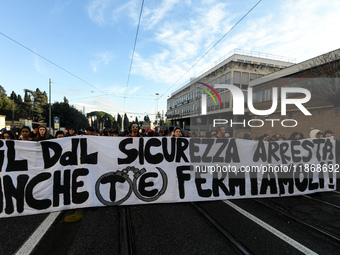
[15,212,60,255]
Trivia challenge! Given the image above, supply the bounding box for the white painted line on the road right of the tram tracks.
[223,200,317,255]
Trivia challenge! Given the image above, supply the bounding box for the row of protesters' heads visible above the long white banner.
[0,122,334,141]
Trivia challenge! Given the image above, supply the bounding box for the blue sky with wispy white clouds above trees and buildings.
[0,0,340,119]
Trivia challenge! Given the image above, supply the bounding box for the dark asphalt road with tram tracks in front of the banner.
[0,192,340,254]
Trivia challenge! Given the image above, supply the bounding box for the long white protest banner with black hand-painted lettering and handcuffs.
[0,131,339,217]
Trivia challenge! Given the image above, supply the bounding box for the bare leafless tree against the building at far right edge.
[303,50,340,106]
